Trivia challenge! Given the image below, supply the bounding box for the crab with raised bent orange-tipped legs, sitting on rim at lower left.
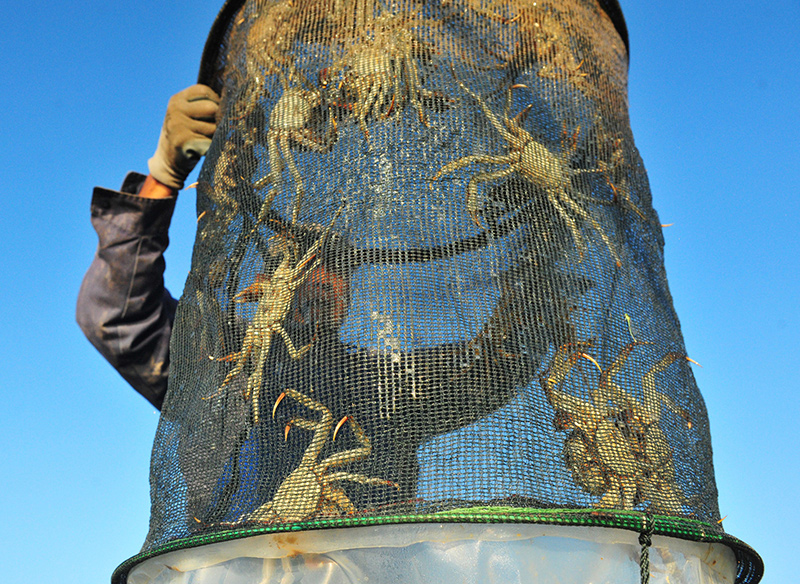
[243,389,399,523]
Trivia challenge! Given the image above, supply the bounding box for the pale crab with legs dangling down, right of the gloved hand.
[254,87,337,223]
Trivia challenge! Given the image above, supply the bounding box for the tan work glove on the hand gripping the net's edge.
[147,85,219,189]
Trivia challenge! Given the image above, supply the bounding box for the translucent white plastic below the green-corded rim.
[128,523,736,584]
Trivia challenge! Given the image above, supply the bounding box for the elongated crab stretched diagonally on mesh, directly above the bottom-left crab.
[211,205,344,424]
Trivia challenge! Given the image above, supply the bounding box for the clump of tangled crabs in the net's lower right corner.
[542,342,691,515]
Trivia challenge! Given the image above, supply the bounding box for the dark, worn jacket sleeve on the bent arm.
[77,173,177,409]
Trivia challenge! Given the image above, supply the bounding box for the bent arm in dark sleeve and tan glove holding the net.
[77,85,219,409]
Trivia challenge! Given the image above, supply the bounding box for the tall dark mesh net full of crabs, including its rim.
[115,0,761,582]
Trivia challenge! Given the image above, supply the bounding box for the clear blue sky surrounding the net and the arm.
[0,0,800,584]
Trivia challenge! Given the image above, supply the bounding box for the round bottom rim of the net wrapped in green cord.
[111,507,764,584]
